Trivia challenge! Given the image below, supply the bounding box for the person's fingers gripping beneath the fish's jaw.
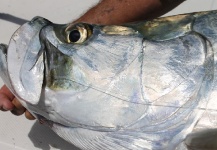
[0,85,35,120]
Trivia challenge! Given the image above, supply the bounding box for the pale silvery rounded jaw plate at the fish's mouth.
[7,17,50,104]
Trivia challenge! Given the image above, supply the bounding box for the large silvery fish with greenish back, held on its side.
[0,11,217,150]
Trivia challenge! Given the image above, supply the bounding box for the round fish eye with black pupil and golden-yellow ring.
[66,24,92,44]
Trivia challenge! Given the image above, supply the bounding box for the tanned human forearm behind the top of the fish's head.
[75,0,184,25]
